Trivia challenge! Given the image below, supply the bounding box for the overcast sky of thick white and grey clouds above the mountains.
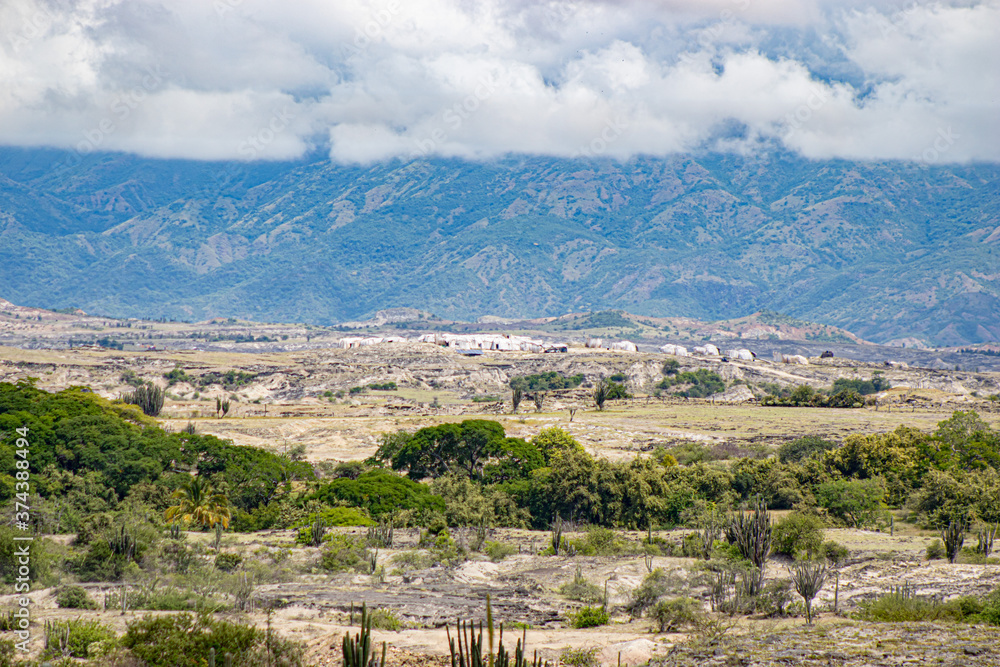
[0,0,1000,163]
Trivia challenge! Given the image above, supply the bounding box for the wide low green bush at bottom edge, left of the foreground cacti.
[121,614,304,667]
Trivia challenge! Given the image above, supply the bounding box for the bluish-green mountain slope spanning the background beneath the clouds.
[0,149,1000,346]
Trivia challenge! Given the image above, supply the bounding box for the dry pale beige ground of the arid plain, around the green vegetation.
[0,306,1000,665]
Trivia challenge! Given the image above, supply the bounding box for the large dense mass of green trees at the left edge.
[0,382,314,532]
